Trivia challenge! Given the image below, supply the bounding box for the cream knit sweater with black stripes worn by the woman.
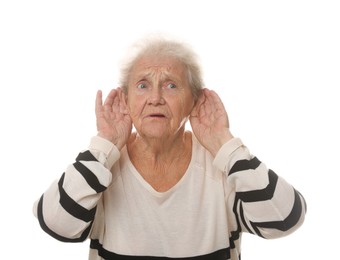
[34,135,306,260]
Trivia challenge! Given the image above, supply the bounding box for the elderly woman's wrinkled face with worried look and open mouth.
[127,57,195,138]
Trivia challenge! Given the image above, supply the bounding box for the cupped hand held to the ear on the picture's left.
[96,88,132,150]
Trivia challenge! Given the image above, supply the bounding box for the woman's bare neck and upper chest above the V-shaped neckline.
[127,131,192,192]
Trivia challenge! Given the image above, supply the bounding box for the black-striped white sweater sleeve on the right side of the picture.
[213,138,306,238]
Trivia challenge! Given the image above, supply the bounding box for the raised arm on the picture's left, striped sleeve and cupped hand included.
[34,88,132,242]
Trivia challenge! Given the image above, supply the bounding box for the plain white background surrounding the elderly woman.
[0,0,340,260]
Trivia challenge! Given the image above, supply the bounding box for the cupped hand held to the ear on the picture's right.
[190,89,233,156]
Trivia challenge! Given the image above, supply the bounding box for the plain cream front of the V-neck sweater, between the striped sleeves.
[93,135,229,257]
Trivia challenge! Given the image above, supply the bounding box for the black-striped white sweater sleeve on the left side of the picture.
[33,136,120,242]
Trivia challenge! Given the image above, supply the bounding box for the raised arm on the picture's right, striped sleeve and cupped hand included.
[190,89,306,238]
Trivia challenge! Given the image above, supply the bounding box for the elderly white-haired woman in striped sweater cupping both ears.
[34,36,305,260]
